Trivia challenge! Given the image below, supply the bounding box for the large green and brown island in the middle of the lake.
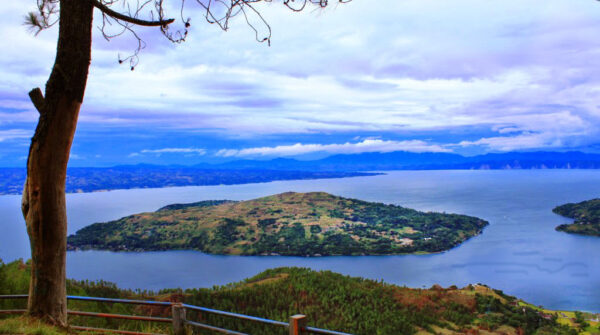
[68,192,488,256]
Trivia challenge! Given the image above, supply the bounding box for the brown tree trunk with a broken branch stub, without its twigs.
[22,0,93,326]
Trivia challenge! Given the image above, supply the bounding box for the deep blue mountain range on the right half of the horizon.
[189,151,600,171]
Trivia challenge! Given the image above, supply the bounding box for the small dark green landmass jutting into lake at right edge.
[552,199,600,236]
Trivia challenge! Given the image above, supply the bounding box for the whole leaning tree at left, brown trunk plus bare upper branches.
[22,0,350,326]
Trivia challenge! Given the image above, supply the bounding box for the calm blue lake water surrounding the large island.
[0,170,600,312]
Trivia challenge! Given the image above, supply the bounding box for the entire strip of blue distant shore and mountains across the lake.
[0,151,600,194]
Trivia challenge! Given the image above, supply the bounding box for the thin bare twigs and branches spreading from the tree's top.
[25,0,352,70]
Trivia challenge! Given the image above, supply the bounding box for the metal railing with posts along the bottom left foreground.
[0,294,351,335]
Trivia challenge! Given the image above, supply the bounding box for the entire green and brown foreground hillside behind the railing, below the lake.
[0,260,599,335]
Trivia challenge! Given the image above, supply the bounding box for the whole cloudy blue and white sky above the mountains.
[0,0,600,166]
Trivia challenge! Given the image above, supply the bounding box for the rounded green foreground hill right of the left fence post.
[185,268,576,335]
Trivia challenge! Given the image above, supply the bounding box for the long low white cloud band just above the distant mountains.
[216,139,450,157]
